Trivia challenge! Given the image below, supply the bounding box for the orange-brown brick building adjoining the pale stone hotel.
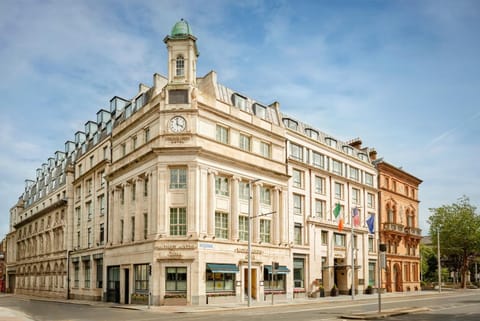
[374,159,422,292]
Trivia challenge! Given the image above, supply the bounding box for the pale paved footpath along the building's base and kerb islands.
[0,291,464,321]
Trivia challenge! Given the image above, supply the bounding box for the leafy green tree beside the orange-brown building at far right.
[428,196,480,288]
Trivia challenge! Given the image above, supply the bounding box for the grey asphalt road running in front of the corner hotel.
[0,290,480,321]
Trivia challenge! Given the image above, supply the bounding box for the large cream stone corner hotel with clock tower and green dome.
[7,20,422,305]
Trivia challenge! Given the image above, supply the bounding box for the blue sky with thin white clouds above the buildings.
[0,0,480,239]
